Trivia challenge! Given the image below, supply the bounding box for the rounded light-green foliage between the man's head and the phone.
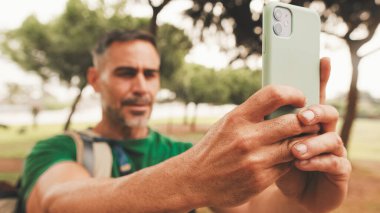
[172,64,261,104]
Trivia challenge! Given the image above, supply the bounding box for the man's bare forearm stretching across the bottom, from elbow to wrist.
[43,156,200,212]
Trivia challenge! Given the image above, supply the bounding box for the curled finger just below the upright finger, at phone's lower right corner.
[297,105,339,132]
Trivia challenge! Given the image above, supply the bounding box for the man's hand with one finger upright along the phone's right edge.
[276,59,351,212]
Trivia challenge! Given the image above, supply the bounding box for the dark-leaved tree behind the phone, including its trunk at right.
[186,0,380,146]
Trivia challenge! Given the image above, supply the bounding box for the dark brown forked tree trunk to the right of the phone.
[340,44,360,147]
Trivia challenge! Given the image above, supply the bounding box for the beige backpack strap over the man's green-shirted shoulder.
[66,130,113,178]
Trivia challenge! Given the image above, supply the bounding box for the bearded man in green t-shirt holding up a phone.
[22,31,351,212]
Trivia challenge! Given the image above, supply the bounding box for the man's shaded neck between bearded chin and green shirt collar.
[93,118,149,140]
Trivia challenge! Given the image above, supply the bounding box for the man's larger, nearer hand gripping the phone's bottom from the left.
[182,86,320,207]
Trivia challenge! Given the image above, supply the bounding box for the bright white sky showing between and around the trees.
[0,0,380,99]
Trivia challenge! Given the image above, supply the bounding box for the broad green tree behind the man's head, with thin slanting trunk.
[2,0,191,130]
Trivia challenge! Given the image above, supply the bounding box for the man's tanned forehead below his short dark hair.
[105,40,160,69]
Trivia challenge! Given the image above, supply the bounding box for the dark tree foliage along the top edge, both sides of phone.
[185,0,380,59]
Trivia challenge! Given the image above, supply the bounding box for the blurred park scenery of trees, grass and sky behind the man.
[0,0,380,212]
